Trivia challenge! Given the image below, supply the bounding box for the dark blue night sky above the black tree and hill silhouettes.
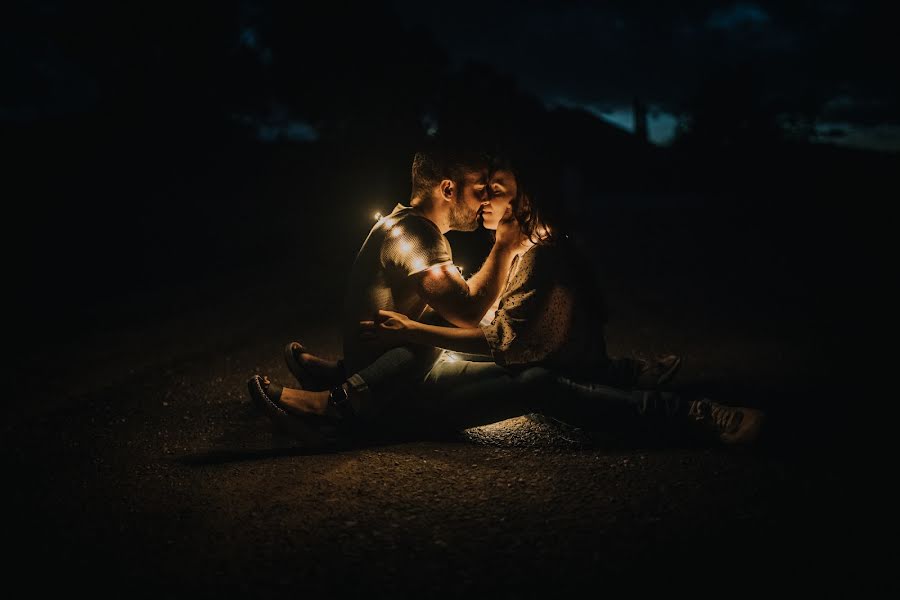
[7,0,900,150]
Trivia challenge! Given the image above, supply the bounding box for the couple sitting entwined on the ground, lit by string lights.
[248,145,763,443]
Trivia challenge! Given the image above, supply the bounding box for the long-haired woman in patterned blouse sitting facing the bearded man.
[251,157,761,442]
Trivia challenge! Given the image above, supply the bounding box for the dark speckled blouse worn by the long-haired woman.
[481,245,609,376]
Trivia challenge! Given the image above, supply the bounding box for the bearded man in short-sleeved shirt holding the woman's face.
[248,144,521,429]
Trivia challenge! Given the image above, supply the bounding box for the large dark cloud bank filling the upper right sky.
[394,0,900,131]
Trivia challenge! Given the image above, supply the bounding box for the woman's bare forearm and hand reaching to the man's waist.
[360,310,491,355]
